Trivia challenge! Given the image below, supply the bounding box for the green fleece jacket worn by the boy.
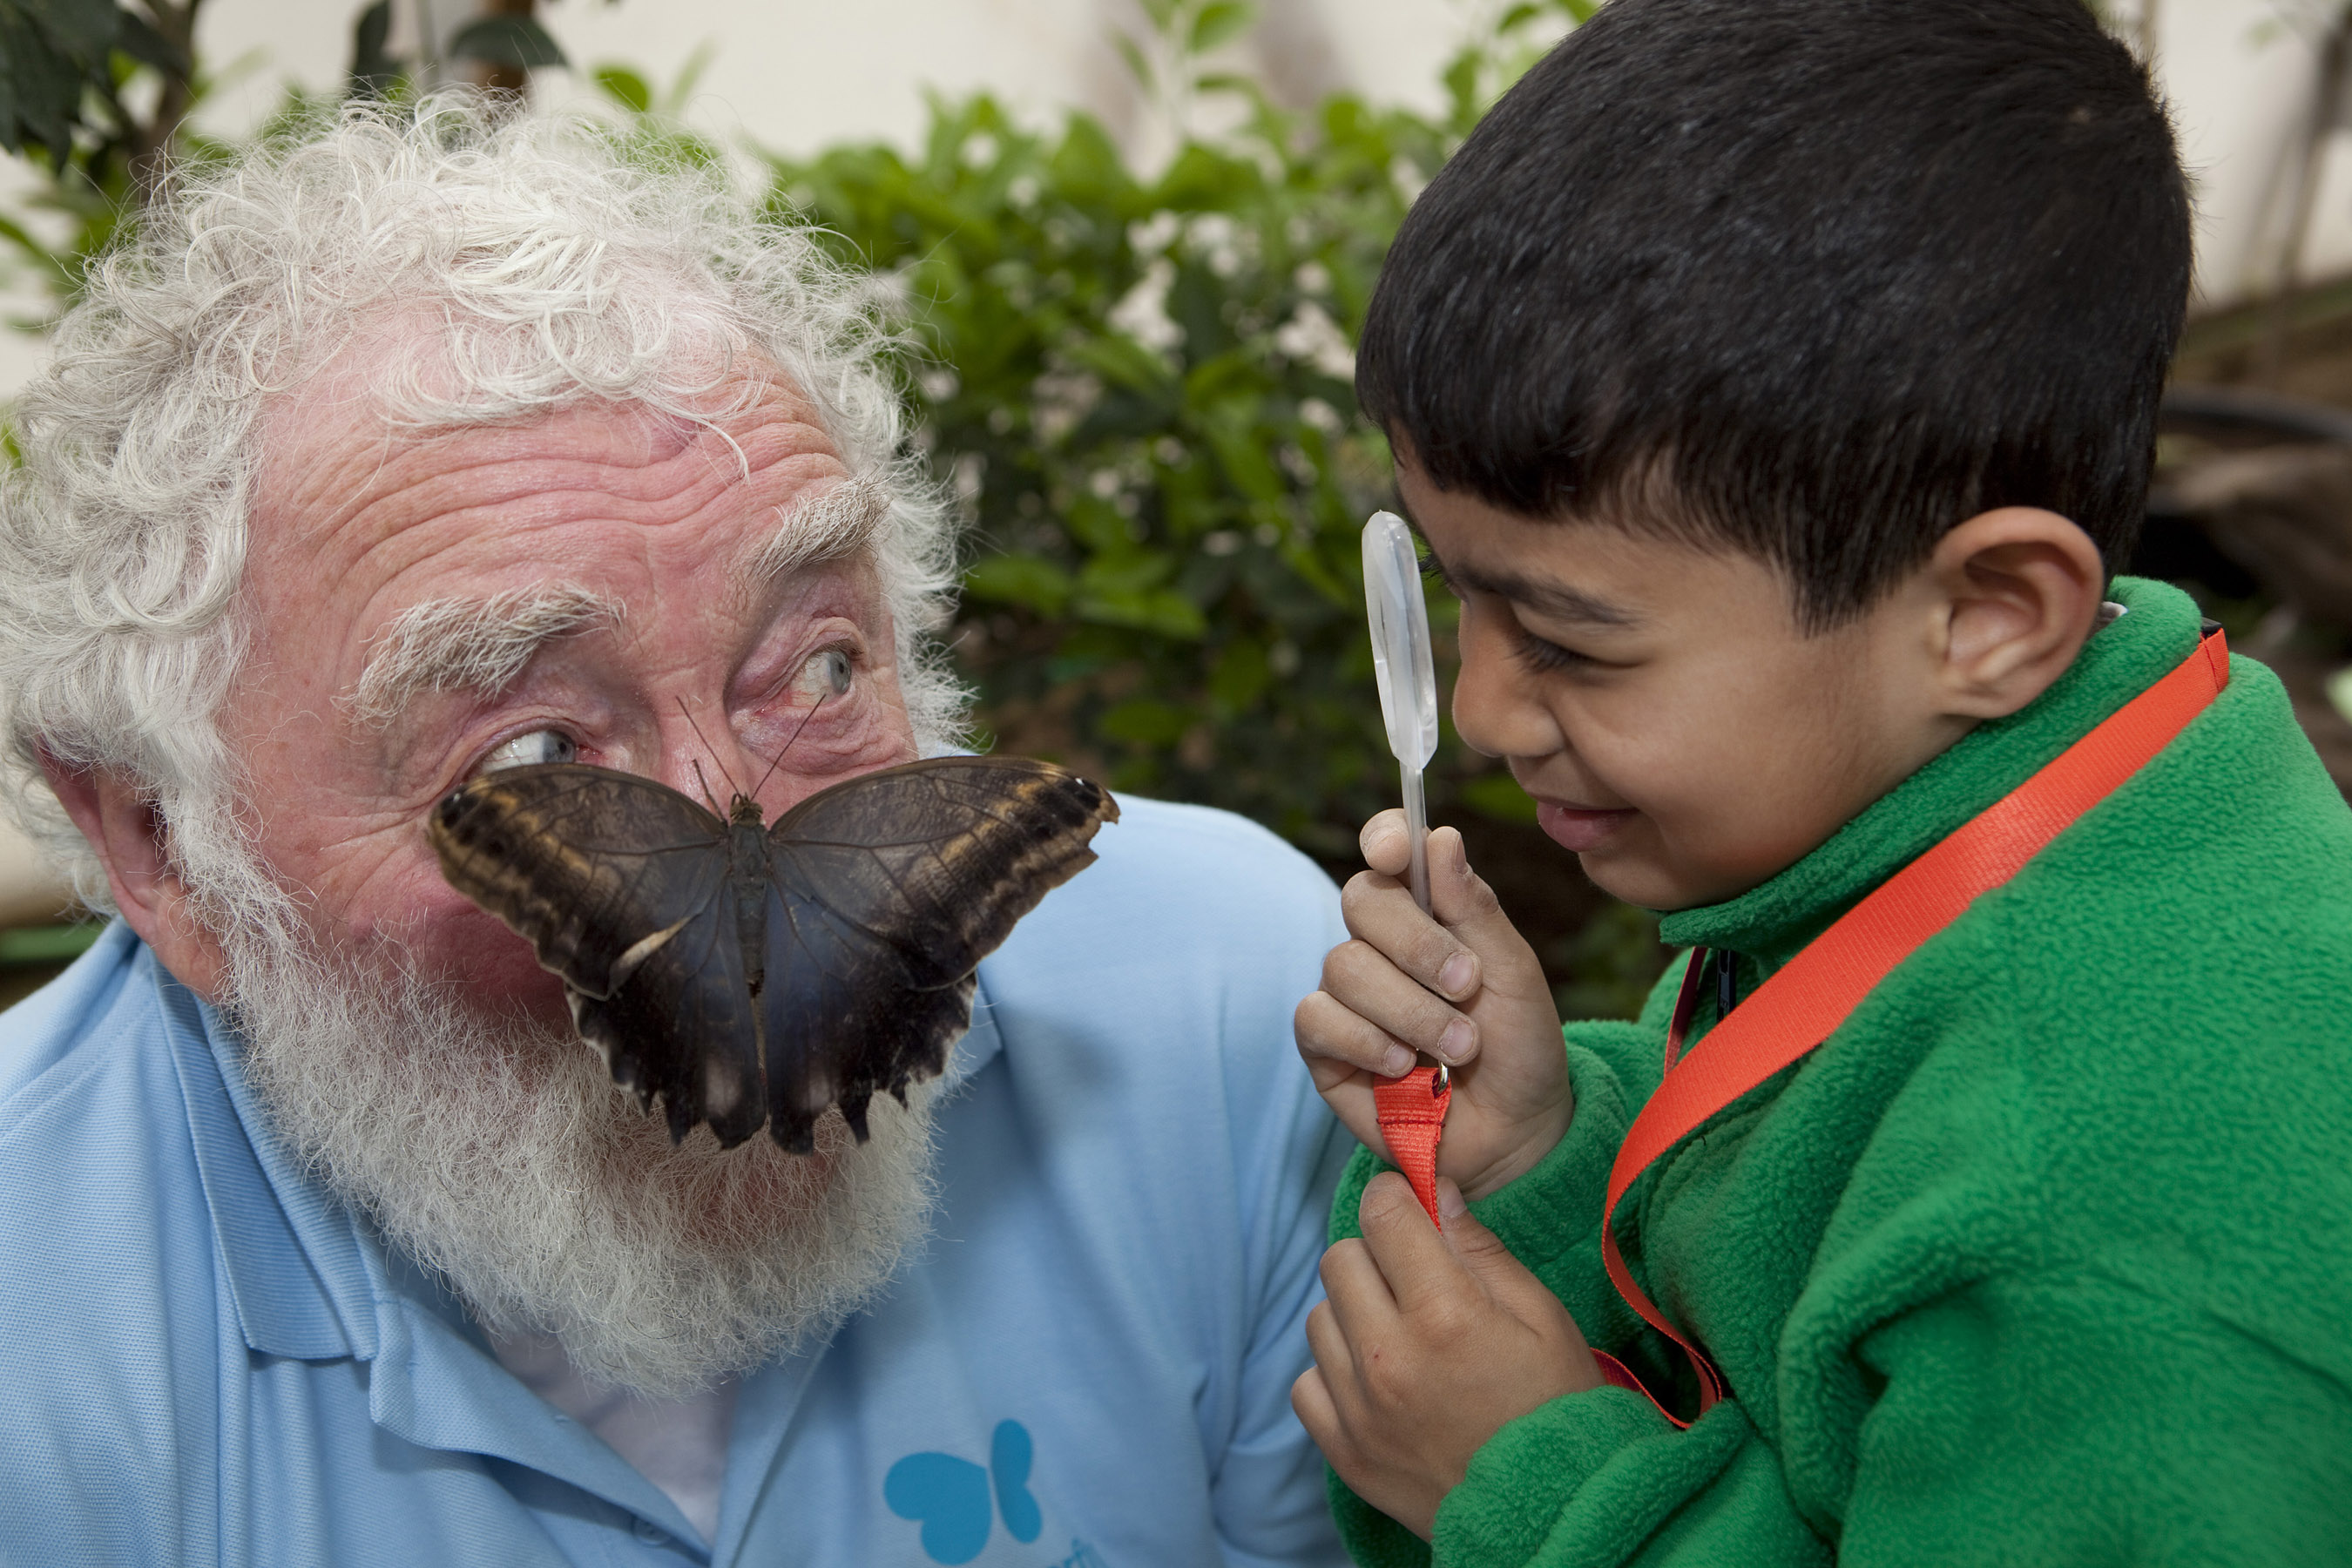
[1331,578,2352,1568]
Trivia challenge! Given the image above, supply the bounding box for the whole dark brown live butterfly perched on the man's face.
[426,757,1119,1154]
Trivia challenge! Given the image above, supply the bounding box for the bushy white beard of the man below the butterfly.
[224,922,934,1399]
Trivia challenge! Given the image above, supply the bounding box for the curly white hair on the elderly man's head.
[0,94,964,919]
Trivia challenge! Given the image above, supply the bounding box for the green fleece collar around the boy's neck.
[1659,578,2200,969]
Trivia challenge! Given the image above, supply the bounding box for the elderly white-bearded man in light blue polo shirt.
[0,104,1343,1568]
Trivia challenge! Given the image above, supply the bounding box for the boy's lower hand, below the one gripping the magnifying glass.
[1291,1171,1602,1540]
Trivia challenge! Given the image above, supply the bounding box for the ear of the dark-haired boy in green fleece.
[1924,505,2107,720]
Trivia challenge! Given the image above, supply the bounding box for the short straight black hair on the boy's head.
[1357,0,2190,630]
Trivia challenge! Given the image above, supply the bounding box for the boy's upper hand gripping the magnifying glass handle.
[1294,811,1573,1197]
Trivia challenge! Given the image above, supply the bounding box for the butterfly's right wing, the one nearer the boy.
[760,757,1119,1152]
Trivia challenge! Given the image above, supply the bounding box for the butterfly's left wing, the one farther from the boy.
[426,761,767,1145]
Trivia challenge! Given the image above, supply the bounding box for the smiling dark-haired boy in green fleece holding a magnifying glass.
[1294,0,2352,1565]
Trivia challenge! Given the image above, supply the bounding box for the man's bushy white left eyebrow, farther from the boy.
[341,583,624,729]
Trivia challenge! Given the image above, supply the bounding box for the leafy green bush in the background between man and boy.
[753,0,1655,858]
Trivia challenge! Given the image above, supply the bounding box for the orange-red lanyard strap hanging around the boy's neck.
[1595,630,2230,1427]
